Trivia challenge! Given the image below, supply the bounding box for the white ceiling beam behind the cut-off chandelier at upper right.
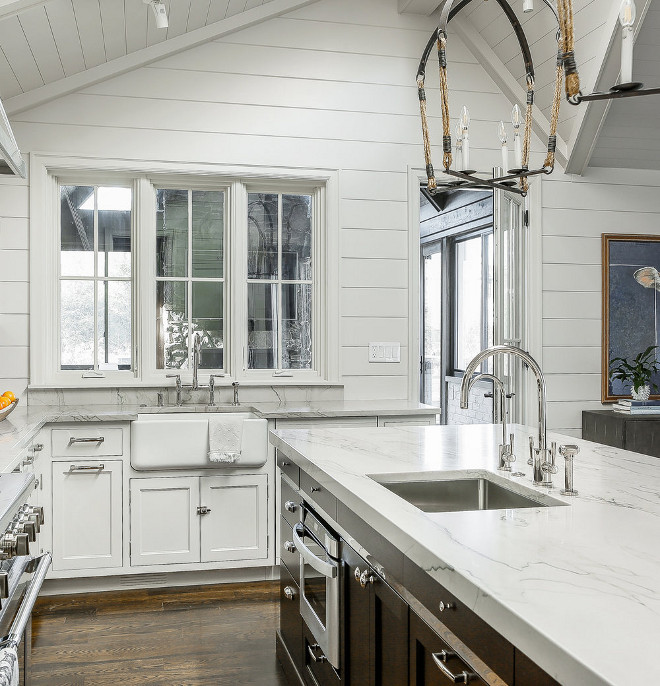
[566,0,653,176]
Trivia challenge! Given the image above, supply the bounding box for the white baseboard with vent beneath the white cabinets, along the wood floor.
[41,567,280,596]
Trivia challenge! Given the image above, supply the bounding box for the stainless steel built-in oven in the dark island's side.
[293,502,341,669]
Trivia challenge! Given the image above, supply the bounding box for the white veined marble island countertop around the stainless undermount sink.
[271,425,660,686]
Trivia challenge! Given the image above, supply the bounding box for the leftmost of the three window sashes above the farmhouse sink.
[58,185,133,372]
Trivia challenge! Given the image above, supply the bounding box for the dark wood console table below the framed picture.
[582,410,660,457]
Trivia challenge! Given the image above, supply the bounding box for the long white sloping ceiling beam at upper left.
[5,0,318,116]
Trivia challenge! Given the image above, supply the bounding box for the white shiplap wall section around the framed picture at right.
[543,169,660,435]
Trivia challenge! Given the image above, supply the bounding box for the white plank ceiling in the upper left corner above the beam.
[0,0,272,101]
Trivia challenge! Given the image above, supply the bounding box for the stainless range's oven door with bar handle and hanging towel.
[0,553,51,686]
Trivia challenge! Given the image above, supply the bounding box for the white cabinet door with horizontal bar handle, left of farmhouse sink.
[52,460,122,571]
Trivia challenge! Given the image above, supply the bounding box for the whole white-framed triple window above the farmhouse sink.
[30,160,338,387]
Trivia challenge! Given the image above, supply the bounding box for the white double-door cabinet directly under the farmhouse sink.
[130,474,268,566]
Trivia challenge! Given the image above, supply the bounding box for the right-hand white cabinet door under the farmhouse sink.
[200,474,268,562]
